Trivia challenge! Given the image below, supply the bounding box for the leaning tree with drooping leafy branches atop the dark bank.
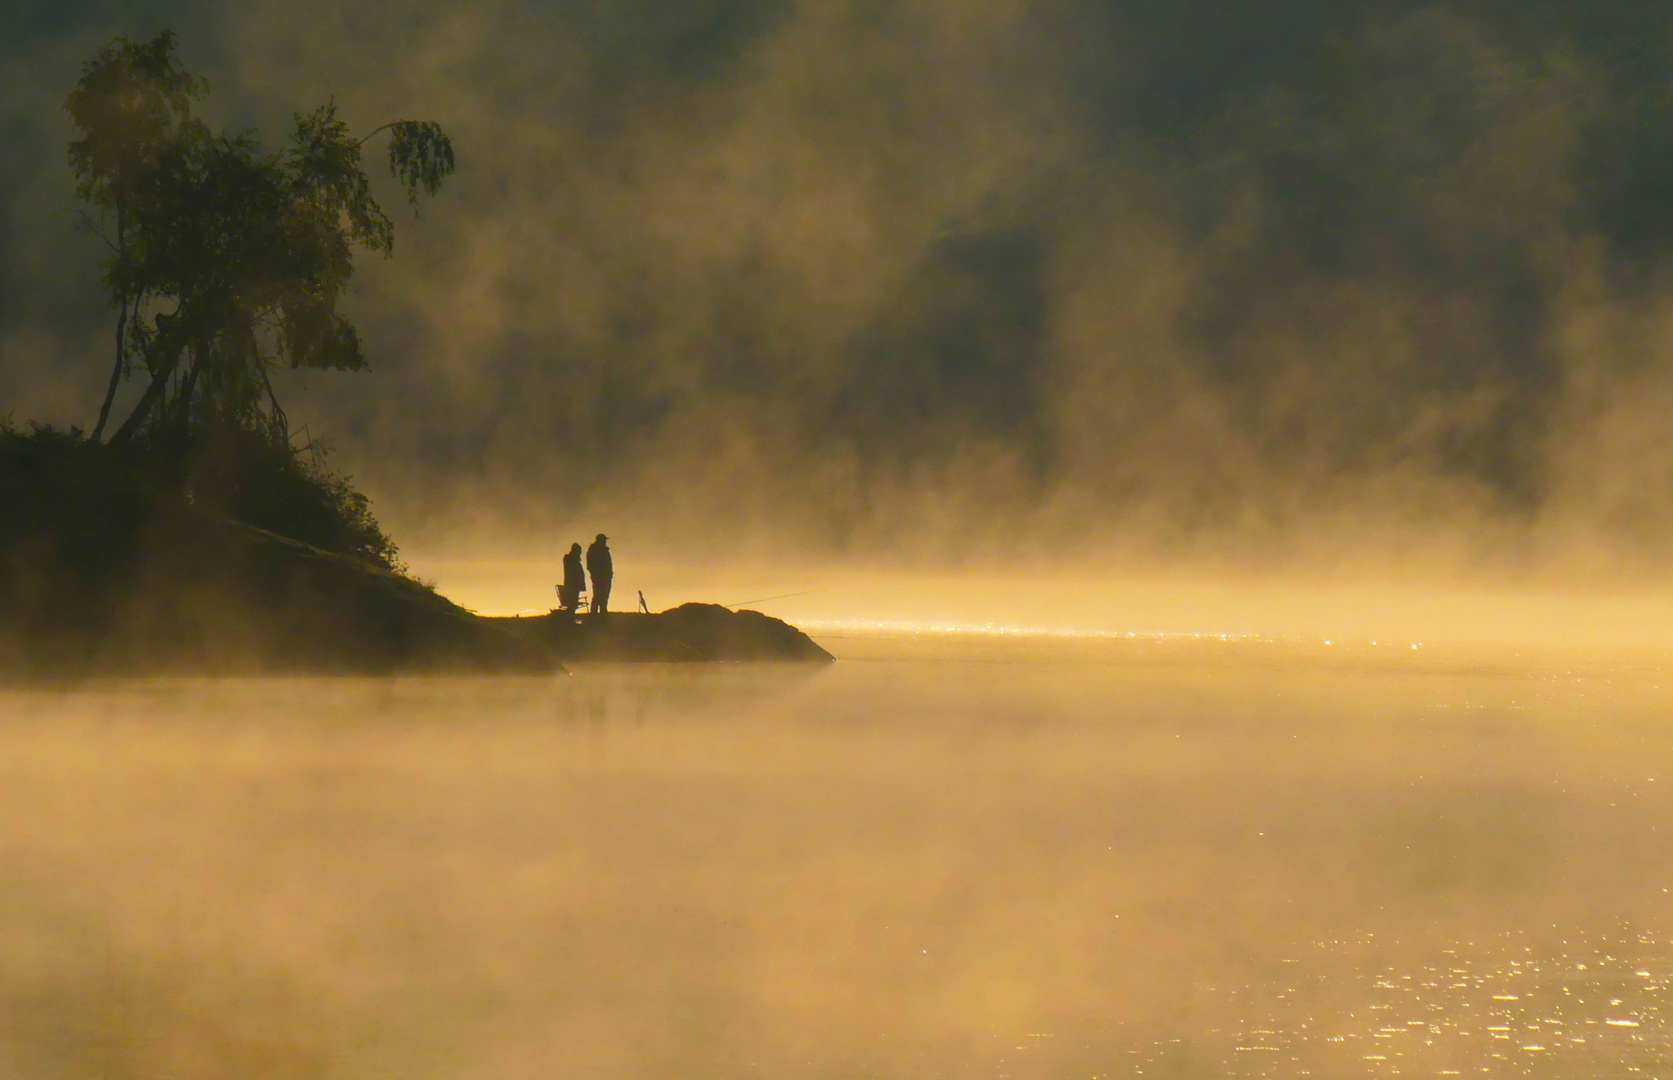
[65,30,453,443]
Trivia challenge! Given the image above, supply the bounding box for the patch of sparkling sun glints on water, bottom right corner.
[1126,926,1673,1077]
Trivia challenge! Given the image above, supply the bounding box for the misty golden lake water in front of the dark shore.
[0,635,1673,1080]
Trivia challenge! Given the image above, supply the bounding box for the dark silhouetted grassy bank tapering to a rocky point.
[0,425,830,679]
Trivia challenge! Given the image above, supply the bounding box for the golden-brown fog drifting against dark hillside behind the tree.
[0,0,1673,577]
